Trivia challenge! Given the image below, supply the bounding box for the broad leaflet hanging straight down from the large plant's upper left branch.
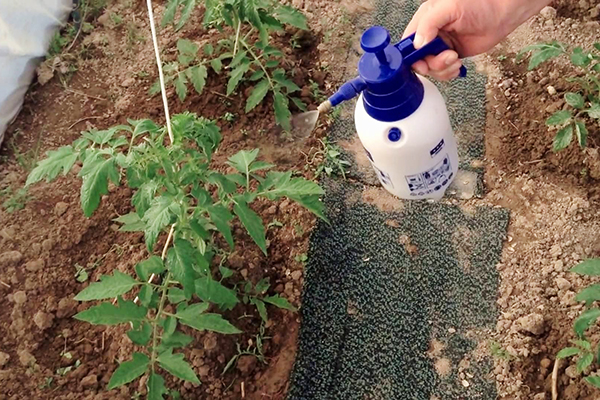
[79,156,121,217]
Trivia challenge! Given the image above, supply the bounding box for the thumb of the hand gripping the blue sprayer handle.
[413,0,455,49]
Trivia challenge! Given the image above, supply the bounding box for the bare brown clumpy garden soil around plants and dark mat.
[0,0,600,400]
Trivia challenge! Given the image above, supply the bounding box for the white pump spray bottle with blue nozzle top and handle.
[319,26,466,200]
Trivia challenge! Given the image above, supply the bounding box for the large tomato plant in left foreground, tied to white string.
[26,112,325,398]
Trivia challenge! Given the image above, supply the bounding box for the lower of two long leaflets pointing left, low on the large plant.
[73,300,148,325]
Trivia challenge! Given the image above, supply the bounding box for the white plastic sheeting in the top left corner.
[0,0,73,144]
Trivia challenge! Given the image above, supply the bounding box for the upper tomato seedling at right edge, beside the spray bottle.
[517,41,600,152]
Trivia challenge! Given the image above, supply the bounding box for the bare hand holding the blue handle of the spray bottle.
[403,0,551,80]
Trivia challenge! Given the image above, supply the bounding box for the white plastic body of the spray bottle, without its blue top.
[354,76,458,200]
